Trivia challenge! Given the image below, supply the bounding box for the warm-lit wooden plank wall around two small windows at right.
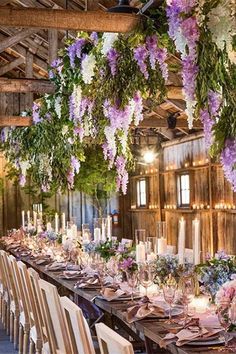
[122,136,236,256]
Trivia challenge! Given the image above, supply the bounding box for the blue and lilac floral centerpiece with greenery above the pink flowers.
[196,251,236,302]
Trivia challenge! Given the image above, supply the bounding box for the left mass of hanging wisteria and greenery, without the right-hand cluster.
[2,17,168,195]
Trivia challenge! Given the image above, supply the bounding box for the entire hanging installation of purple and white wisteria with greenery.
[2,0,236,193]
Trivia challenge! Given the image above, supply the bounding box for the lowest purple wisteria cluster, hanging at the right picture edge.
[220,138,236,192]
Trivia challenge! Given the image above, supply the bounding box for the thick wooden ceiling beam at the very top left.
[0,7,141,33]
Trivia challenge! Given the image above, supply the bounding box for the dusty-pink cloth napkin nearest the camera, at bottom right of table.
[160,326,222,348]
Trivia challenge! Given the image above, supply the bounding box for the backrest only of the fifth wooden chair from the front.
[17,261,42,339]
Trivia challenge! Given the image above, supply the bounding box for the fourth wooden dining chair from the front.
[28,268,53,353]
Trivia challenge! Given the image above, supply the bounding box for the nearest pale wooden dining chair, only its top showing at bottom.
[95,323,134,354]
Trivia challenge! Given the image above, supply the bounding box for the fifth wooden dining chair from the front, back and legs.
[17,261,43,354]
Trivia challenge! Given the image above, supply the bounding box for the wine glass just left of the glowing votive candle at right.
[180,276,195,323]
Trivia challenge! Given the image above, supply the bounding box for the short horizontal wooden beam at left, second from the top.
[0,78,55,94]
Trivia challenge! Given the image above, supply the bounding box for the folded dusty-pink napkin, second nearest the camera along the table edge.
[126,298,165,323]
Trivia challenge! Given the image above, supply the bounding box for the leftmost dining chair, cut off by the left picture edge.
[0,251,10,329]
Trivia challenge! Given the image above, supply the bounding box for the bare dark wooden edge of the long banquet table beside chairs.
[1,244,232,354]
